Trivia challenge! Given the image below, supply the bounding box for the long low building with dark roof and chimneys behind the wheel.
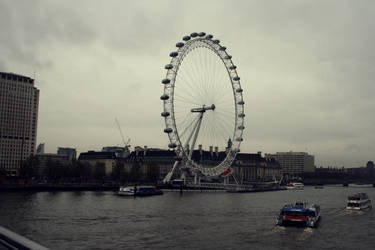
[124,145,281,184]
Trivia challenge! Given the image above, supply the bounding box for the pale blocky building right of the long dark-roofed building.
[265,151,315,176]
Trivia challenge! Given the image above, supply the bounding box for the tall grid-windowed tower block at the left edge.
[0,72,39,174]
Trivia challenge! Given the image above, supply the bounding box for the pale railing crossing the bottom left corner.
[0,226,48,250]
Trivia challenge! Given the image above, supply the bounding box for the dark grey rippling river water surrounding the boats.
[0,186,375,249]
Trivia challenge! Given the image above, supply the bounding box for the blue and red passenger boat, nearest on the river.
[277,201,320,227]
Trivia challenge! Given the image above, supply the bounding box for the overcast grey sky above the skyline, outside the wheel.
[0,0,375,167]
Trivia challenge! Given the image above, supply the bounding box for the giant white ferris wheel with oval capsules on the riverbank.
[160,32,245,181]
